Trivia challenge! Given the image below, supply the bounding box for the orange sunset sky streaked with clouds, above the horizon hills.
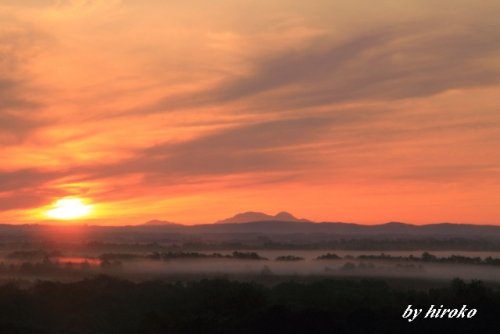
[0,0,500,225]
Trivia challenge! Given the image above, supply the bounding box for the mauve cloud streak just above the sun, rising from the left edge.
[0,115,370,197]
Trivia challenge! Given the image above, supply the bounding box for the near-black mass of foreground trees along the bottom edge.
[0,276,500,334]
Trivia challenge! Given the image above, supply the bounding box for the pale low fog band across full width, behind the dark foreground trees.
[0,250,500,282]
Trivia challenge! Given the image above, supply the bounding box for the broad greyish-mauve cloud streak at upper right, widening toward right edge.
[125,22,500,114]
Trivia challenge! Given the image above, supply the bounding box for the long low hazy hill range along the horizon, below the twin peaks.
[0,220,500,241]
